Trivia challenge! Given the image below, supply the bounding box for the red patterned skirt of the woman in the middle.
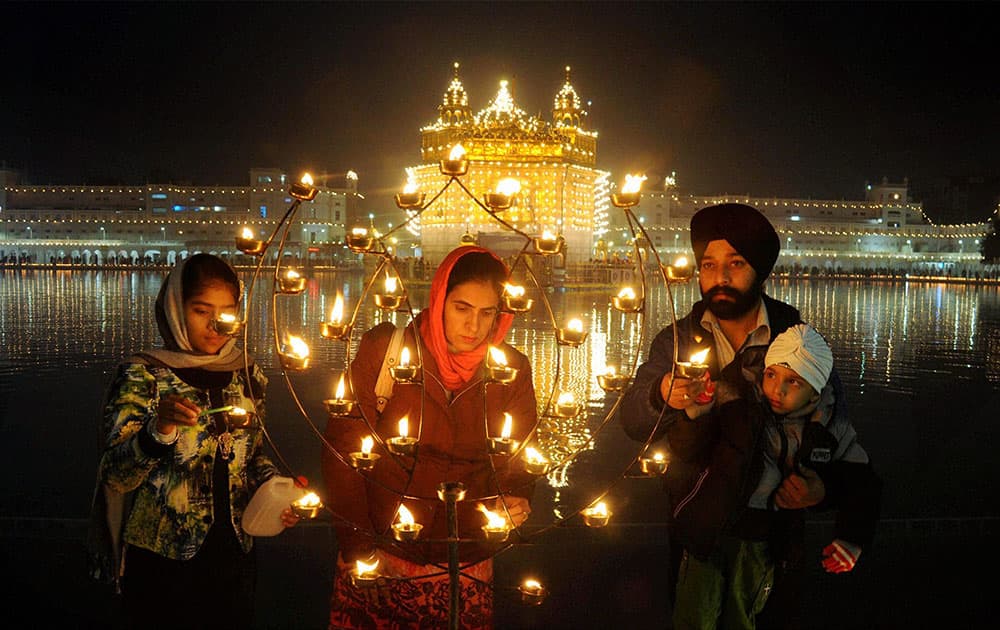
[330,553,493,630]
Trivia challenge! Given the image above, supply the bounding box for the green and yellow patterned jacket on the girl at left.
[99,362,278,560]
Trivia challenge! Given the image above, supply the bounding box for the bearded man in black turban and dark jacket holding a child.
[618,203,870,629]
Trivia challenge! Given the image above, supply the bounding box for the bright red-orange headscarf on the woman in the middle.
[419,245,514,391]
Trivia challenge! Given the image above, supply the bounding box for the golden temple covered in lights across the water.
[407,63,609,264]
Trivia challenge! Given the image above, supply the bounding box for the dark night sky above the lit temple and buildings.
[0,2,1000,220]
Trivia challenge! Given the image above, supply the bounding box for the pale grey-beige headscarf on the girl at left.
[139,254,253,372]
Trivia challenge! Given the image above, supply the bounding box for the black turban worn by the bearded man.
[691,203,781,282]
